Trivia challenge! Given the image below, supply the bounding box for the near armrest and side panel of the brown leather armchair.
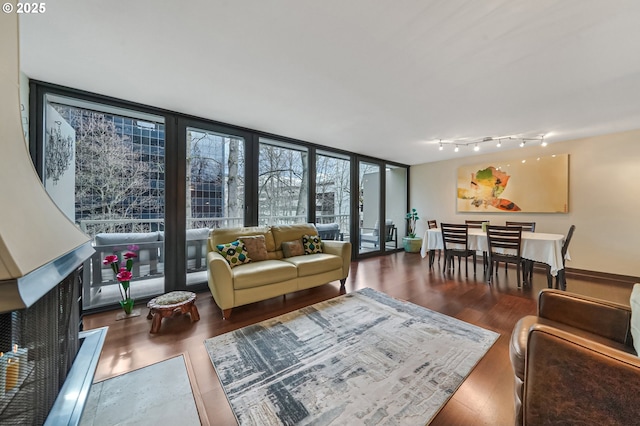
[522,324,640,424]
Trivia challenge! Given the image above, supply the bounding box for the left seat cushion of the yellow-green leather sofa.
[232,260,298,290]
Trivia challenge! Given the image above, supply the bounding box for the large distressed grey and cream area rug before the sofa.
[205,288,499,426]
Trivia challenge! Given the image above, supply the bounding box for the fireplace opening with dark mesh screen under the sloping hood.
[0,270,100,426]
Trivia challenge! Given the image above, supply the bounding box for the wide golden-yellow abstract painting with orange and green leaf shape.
[457,154,569,213]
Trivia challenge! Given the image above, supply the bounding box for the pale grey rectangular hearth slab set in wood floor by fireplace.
[80,355,200,426]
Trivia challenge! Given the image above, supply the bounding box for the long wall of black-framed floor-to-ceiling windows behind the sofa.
[30,82,407,310]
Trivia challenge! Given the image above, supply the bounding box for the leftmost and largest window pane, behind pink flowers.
[43,95,165,309]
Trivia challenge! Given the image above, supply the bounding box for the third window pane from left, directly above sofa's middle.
[258,138,309,225]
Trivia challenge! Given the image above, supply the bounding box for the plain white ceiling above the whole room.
[20,0,640,164]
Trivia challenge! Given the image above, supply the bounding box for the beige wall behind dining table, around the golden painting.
[410,130,640,277]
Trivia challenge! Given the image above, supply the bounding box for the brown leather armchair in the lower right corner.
[509,289,640,425]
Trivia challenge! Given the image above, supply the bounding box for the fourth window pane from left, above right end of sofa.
[315,150,351,241]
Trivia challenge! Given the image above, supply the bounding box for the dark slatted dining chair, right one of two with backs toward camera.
[487,225,526,288]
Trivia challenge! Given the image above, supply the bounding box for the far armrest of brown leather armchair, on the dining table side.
[538,289,632,346]
